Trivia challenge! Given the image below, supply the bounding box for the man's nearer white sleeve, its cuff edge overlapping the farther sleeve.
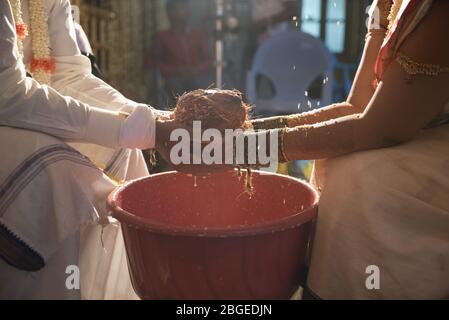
[0,0,125,146]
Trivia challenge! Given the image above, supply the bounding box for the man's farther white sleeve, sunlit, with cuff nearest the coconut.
[44,0,155,147]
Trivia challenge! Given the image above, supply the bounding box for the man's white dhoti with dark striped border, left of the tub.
[0,127,148,299]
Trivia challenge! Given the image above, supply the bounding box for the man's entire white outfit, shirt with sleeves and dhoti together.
[0,0,155,299]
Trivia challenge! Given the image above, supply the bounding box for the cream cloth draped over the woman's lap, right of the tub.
[308,125,449,299]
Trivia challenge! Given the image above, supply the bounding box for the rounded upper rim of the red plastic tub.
[107,170,319,238]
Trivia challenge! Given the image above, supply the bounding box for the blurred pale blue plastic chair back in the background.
[246,30,333,116]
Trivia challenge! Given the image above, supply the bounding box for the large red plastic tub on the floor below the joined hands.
[108,172,318,299]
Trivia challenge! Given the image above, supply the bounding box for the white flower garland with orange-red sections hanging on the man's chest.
[10,0,56,85]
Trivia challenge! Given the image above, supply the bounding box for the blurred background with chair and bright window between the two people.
[72,0,372,178]
